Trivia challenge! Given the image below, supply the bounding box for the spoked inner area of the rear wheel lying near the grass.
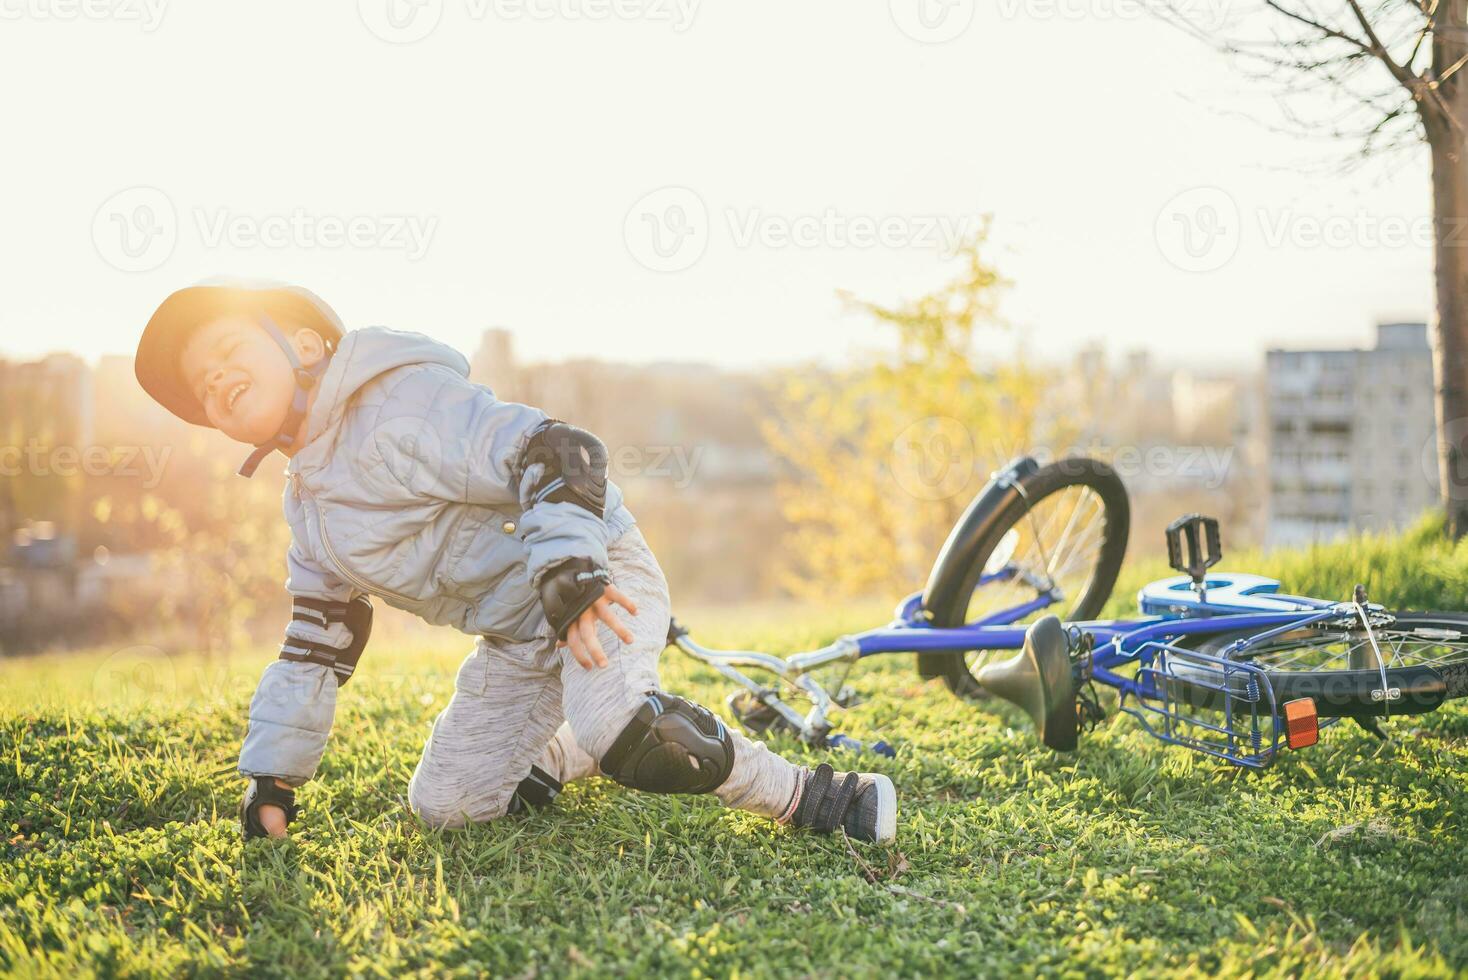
[1235,622,1468,672]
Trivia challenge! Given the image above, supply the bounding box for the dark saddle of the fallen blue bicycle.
[979,616,1078,753]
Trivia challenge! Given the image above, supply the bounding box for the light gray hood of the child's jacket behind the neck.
[292,327,468,462]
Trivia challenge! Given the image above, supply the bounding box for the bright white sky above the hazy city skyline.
[0,0,1431,368]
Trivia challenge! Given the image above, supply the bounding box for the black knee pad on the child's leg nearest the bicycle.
[602,691,734,792]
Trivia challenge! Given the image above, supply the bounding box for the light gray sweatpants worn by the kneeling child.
[408,527,797,827]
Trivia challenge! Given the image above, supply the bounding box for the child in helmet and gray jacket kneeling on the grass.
[135,285,897,842]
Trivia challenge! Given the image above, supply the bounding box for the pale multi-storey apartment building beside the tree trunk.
[1265,323,1439,546]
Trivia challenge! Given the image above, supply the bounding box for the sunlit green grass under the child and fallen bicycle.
[0,528,1468,977]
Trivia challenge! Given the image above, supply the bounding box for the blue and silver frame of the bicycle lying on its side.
[669,565,1368,767]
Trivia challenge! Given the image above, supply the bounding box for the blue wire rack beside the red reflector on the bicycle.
[1120,641,1327,769]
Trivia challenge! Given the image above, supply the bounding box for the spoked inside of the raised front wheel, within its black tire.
[963,486,1107,673]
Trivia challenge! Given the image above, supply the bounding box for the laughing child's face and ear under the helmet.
[179,315,324,446]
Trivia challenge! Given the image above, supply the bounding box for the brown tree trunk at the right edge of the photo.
[1418,11,1468,540]
